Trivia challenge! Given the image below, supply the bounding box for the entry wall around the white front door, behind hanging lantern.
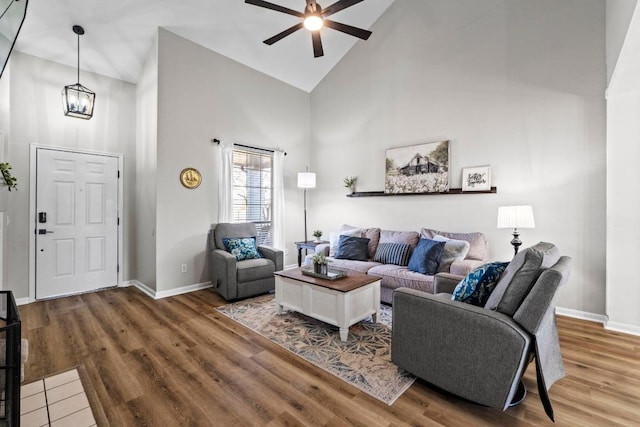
[3,51,136,298]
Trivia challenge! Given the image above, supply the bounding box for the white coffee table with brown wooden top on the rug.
[275,268,380,342]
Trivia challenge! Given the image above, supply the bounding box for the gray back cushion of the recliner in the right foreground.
[484,242,560,316]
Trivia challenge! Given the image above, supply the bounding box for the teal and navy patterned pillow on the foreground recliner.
[451,262,509,307]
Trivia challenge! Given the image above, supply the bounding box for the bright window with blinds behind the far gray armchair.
[232,146,273,246]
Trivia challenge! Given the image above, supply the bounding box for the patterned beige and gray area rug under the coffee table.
[217,295,415,405]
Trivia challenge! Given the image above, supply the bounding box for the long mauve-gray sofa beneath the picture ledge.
[305,224,489,304]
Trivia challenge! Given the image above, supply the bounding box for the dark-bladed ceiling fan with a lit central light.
[245,0,371,58]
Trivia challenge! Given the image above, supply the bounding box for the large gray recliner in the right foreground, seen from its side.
[391,242,571,419]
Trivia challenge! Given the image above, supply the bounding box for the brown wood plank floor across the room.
[20,287,640,427]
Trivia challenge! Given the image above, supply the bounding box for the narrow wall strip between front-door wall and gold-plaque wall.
[133,36,158,290]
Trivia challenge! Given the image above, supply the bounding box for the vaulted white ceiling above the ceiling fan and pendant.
[15,0,394,92]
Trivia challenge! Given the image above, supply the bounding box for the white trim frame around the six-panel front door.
[28,143,125,303]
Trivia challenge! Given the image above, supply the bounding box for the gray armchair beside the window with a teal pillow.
[209,223,284,300]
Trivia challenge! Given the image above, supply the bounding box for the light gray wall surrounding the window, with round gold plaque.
[155,30,310,292]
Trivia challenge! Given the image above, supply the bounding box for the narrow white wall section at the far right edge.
[607,2,640,335]
